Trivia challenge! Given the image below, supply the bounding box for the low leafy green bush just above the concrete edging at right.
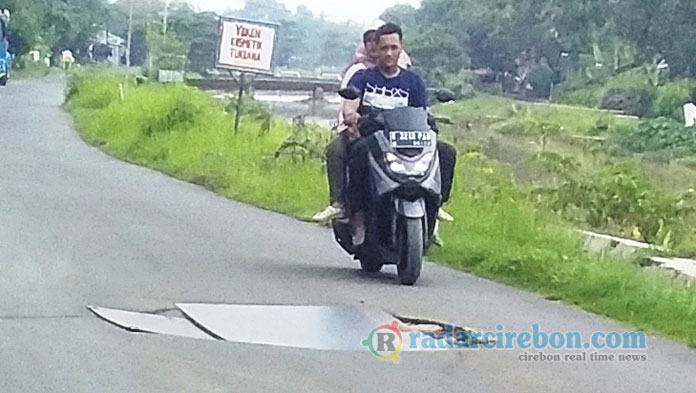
[531,158,696,247]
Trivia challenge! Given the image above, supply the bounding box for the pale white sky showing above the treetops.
[187,0,420,23]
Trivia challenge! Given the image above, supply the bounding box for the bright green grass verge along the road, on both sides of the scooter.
[67,71,696,345]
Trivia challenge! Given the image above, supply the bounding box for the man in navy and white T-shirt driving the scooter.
[343,23,456,245]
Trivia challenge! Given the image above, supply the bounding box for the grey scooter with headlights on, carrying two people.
[332,88,442,285]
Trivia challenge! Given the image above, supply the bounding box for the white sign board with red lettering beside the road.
[215,18,276,73]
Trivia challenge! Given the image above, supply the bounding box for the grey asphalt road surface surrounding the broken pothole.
[0,79,696,393]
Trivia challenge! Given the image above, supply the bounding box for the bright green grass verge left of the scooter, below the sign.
[68,76,328,218]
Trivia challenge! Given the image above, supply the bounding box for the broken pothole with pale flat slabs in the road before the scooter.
[87,303,486,352]
